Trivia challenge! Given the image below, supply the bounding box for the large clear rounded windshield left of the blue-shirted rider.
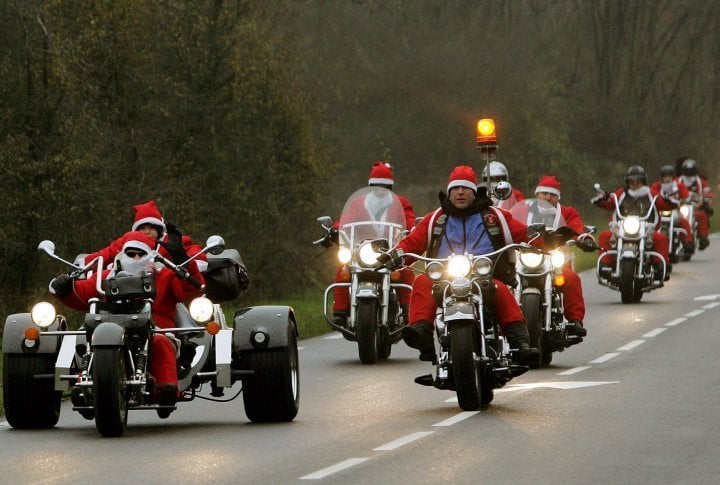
[339,187,405,248]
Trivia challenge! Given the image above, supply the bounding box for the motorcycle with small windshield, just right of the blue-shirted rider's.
[510,199,595,366]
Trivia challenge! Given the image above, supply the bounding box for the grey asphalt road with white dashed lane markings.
[0,234,720,484]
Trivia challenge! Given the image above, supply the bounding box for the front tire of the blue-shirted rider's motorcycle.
[450,321,489,411]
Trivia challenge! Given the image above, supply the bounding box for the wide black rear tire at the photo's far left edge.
[2,354,62,428]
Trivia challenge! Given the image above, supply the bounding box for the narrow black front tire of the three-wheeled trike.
[92,347,128,436]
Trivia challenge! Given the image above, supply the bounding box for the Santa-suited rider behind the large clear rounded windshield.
[333,162,415,314]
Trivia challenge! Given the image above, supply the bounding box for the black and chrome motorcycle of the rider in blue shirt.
[390,243,530,411]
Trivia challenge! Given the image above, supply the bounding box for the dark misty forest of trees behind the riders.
[0,0,720,328]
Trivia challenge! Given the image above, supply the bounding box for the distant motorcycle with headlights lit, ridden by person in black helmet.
[595,184,667,303]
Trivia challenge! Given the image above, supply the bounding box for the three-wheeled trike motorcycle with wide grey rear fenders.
[2,236,299,436]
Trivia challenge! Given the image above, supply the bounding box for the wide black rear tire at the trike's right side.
[241,322,300,422]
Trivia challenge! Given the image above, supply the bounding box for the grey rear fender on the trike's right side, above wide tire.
[233,305,298,352]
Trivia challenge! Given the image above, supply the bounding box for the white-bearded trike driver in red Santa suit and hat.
[51,231,203,394]
